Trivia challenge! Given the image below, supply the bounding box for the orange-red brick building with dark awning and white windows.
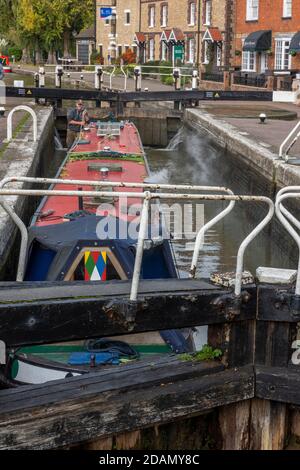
[233,0,300,75]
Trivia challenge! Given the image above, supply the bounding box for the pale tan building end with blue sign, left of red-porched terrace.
[96,0,140,64]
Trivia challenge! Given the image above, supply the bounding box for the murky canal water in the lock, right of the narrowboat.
[147,127,297,278]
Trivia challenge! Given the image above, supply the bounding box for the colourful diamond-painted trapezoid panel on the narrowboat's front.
[65,248,127,282]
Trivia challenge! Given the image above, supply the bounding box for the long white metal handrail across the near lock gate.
[0,178,274,301]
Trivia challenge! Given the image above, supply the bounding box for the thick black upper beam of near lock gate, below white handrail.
[0,279,256,347]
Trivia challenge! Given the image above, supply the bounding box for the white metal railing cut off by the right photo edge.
[275,186,300,295]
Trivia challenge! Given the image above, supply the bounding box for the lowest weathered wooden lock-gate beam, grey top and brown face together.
[0,363,254,449]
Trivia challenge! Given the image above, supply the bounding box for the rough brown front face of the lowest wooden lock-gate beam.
[0,367,254,450]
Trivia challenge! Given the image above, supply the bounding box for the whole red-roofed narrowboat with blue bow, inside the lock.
[8,118,188,384]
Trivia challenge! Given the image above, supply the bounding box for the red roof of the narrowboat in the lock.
[34,122,148,226]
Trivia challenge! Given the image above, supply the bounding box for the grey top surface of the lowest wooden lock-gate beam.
[0,360,224,415]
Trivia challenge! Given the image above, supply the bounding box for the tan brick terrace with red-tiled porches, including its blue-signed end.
[96,0,234,71]
